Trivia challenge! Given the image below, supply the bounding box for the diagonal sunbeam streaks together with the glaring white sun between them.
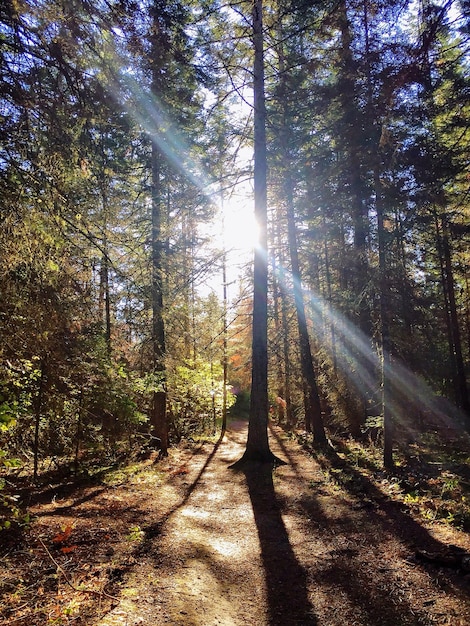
[100,30,466,438]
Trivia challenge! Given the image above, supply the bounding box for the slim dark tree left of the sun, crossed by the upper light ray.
[148,0,209,456]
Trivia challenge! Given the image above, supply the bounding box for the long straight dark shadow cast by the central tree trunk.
[243,463,317,626]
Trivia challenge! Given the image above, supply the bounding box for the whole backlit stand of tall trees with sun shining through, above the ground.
[0,0,470,479]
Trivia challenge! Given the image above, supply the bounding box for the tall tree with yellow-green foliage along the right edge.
[411,2,470,425]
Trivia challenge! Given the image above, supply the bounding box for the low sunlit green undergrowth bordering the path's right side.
[295,433,470,531]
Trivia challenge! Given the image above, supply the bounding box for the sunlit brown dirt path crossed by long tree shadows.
[92,423,470,626]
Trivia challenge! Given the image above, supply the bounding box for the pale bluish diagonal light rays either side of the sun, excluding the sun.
[100,34,465,428]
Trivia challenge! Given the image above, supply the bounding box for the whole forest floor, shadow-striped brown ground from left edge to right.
[0,421,470,626]
